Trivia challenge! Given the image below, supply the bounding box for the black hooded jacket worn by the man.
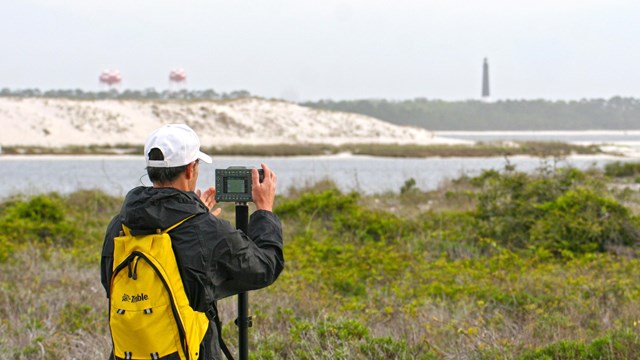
[100,187,284,360]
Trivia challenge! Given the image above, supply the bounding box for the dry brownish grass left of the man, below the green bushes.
[0,247,111,359]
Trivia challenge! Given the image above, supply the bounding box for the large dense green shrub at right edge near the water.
[473,168,640,255]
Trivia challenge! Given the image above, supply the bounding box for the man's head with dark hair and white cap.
[144,124,211,191]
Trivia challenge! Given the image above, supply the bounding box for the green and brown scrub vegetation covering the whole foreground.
[0,166,640,359]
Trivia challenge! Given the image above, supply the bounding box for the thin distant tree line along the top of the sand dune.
[0,88,251,100]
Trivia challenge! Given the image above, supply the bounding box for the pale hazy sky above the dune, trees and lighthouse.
[0,0,640,101]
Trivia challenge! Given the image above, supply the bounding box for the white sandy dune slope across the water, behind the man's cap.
[0,98,464,147]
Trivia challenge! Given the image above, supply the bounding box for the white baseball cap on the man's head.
[144,124,211,168]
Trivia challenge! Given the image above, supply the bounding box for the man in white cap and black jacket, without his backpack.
[100,124,284,360]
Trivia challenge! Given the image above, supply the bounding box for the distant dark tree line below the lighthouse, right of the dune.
[302,97,640,130]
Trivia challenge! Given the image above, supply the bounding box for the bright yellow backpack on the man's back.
[109,217,209,360]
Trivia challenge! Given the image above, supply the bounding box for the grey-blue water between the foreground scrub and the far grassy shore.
[0,155,638,198]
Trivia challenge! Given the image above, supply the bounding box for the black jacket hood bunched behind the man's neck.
[120,186,209,235]
